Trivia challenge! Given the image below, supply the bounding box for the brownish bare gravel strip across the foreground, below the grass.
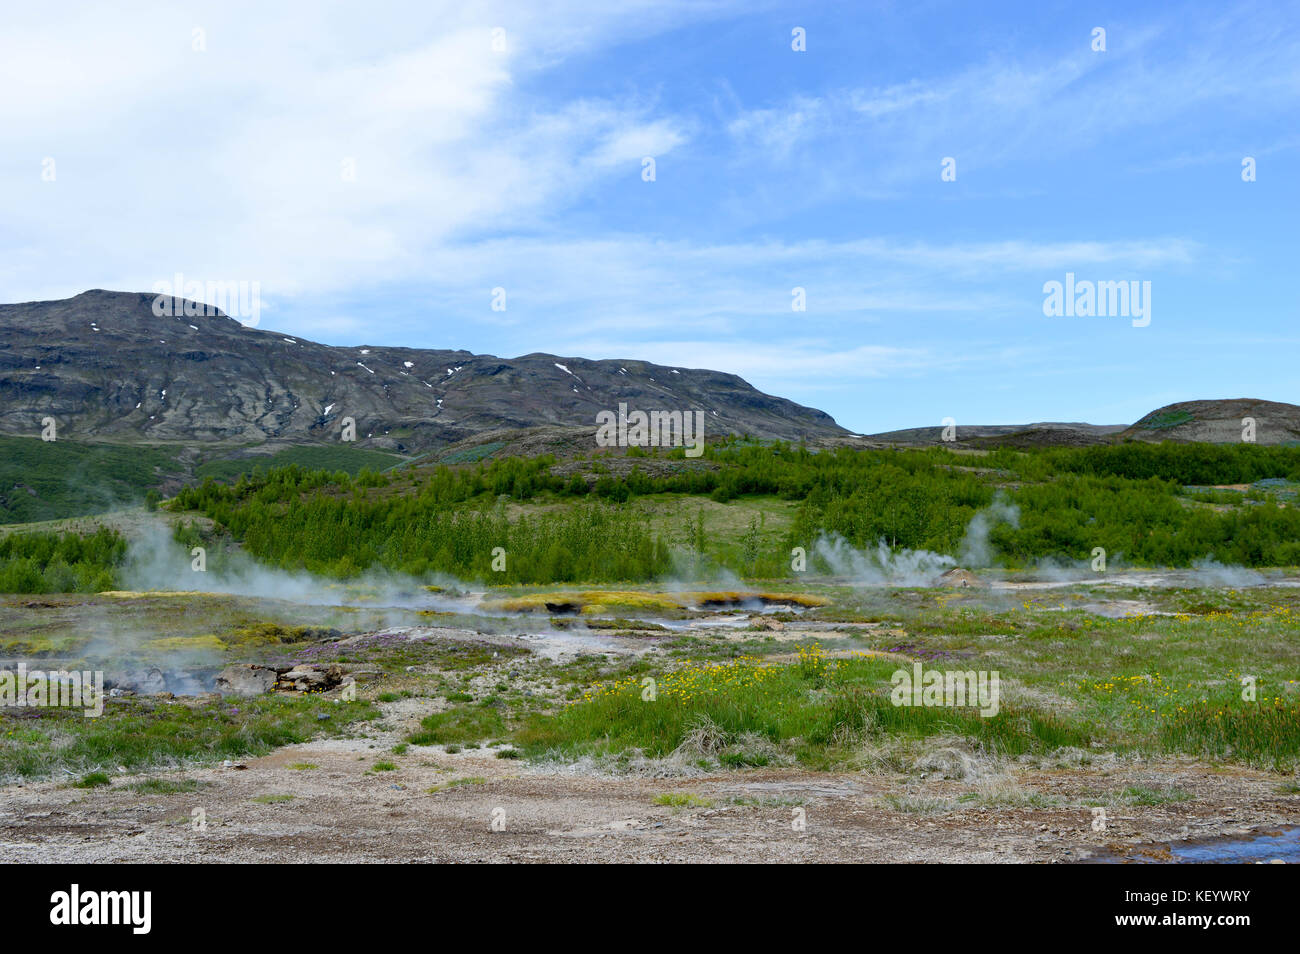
[0,740,1300,863]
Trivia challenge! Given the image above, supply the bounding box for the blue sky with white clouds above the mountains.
[0,0,1300,433]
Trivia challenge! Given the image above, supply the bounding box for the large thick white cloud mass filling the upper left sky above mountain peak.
[0,1,724,300]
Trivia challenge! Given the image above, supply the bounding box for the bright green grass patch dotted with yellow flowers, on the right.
[499,590,1300,772]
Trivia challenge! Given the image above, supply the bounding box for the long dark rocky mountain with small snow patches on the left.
[0,290,848,452]
